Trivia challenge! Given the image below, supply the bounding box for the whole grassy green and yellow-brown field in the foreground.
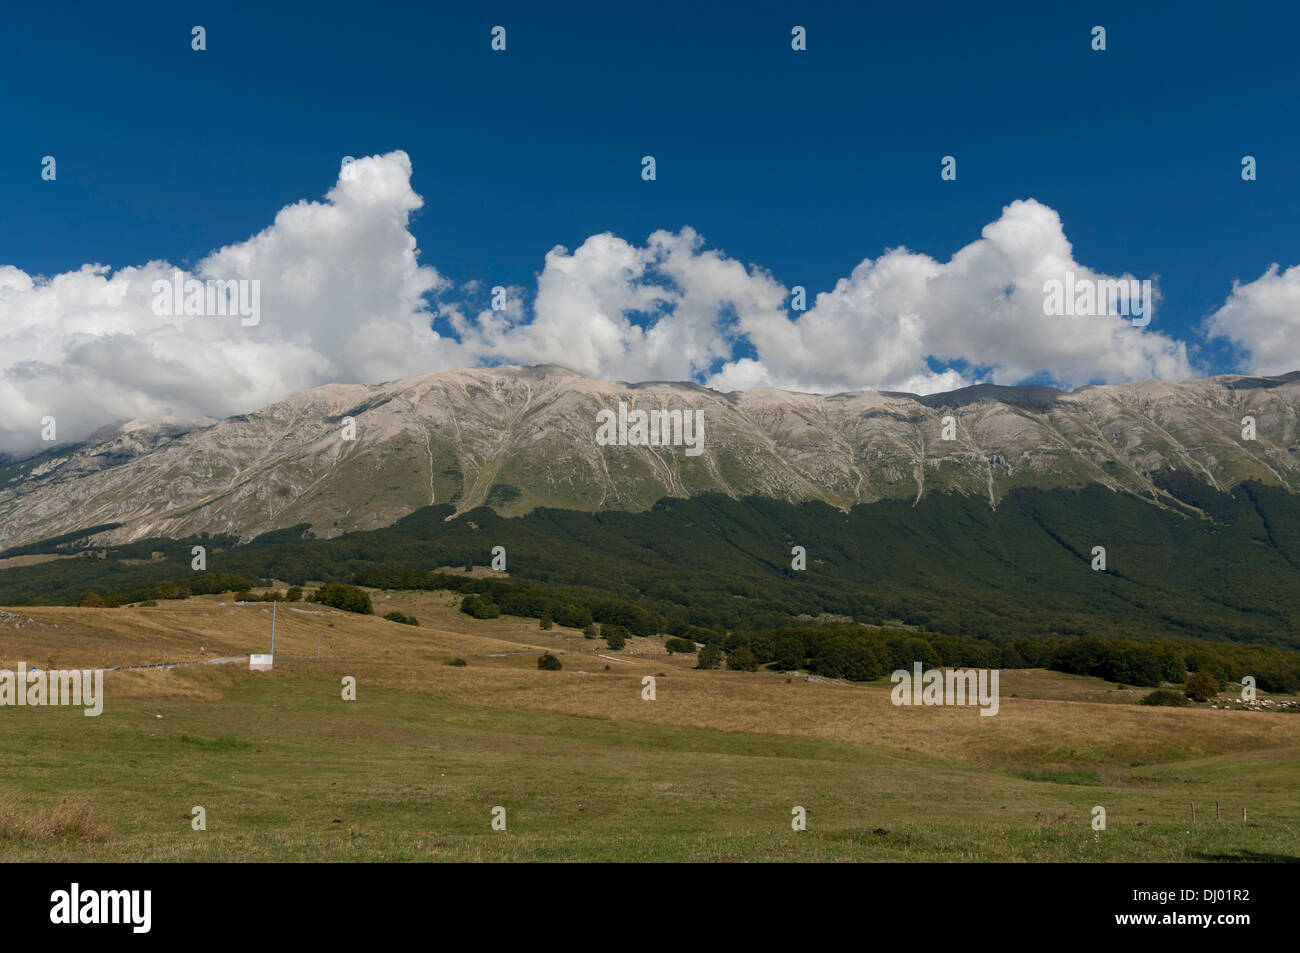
[0,593,1300,861]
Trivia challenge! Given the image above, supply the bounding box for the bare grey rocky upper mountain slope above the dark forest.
[0,365,1300,549]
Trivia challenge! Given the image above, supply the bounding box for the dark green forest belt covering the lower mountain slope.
[0,475,1300,684]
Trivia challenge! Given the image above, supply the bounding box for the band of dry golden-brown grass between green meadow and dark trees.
[0,592,1300,770]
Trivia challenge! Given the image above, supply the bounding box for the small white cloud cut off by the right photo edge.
[1205,264,1300,376]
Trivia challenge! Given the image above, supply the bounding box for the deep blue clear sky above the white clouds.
[0,0,1300,374]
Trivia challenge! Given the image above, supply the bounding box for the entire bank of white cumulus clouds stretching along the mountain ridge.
[0,152,1216,451]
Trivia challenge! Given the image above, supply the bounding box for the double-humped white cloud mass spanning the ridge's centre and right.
[456,200,1192,393]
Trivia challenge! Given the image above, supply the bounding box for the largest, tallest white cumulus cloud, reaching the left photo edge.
[0,152,446,451]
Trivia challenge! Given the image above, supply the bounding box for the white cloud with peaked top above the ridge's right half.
[718,199,1192,393]
